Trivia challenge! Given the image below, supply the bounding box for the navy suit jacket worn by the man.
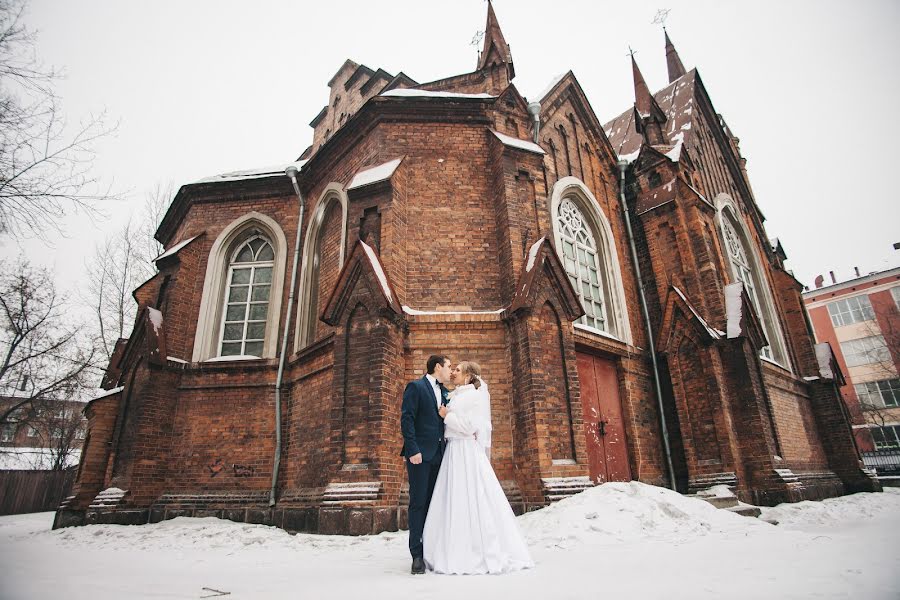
[400,377,446,462]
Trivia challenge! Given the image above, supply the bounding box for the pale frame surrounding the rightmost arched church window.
[716,194,791,370]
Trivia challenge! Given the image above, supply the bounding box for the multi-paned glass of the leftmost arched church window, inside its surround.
[219,235,275,356]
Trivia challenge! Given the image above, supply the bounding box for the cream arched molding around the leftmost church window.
[191,211,287,362]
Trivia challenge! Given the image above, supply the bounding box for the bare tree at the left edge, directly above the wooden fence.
[0,260,99,425]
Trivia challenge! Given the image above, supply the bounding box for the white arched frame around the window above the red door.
[549,177,632,344]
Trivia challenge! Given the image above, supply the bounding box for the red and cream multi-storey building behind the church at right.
[803,267,900,471]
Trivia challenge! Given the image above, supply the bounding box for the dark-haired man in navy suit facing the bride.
[400,355,450,575]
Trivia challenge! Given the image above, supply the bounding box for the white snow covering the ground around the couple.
[0,482,900,600]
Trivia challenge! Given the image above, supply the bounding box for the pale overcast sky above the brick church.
[0,0,900,298]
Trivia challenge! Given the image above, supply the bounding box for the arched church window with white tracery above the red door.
[550,177,631,342]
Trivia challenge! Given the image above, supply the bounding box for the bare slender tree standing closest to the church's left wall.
[84,185,172,361]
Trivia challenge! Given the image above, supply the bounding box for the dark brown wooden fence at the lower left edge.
[0,469,75,515]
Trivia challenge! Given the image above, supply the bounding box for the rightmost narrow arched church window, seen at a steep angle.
[719,198,787,367]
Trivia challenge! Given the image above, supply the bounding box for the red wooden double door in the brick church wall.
[578,352,631,483]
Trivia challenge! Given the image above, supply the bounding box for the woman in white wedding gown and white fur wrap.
[422,362,534,575]
